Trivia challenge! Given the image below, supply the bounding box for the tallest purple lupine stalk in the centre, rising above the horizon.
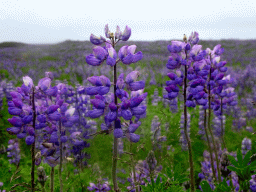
[86,25,144,192]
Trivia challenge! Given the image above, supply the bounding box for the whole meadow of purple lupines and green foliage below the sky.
[0,25,256,192]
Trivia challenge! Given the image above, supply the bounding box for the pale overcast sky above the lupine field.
[0,0,256,44]
